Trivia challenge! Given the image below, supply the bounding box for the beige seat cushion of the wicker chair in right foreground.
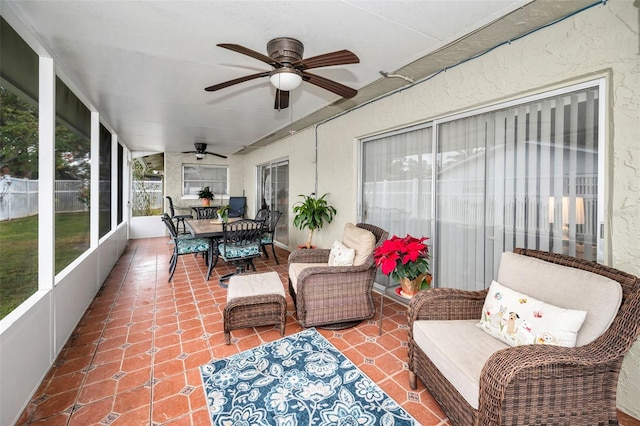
[413,320,509,409]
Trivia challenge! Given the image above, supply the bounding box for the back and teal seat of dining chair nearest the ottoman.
[218,219,264,261]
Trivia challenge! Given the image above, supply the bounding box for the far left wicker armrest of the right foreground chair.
[408,288,488,328]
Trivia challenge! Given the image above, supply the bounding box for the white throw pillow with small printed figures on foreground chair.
[478,281,587,348]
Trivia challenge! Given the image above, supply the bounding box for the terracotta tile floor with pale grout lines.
[18,238,640,426]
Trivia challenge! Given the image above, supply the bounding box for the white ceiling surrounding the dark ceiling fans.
[2,0,592,155]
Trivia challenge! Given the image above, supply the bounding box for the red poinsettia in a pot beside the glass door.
[373,234,431,297]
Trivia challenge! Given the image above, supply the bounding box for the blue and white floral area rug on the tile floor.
[200,329,418,426]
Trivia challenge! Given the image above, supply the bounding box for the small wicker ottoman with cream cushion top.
[223,272,287,345]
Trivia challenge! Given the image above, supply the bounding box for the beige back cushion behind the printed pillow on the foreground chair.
[497,252,622,346]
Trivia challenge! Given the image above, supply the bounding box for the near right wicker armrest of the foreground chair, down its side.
[478,342,623,424]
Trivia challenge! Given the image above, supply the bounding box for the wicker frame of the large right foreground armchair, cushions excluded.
[408,249,640,426]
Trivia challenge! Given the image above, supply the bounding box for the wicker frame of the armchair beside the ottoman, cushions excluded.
[289,223,389,329]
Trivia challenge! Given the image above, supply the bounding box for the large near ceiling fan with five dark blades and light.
[204,37,360,109]
